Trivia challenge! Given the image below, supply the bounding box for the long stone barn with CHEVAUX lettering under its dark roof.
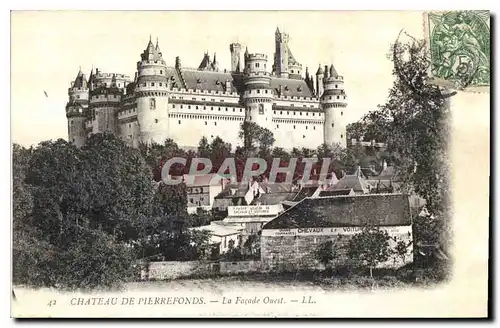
[261,194,413,270]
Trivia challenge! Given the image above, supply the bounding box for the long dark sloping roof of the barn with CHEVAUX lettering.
[263,194,411,229]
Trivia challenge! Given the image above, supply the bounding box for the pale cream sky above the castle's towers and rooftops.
[11,11,424,146]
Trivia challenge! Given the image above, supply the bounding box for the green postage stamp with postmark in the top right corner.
[424,11,491,92]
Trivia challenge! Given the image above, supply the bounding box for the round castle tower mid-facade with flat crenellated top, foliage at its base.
[243,54,274,131]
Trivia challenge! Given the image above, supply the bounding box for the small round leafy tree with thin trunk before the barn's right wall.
[347,226,391,278]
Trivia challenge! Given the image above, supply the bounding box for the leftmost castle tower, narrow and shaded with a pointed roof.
[66,70,89,147]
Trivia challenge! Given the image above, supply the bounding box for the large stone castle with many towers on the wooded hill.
[66,29,347,149]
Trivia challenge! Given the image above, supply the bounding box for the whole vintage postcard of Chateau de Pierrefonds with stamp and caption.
[10,11,491,318]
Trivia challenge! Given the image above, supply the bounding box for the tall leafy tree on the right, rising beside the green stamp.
[367,34,450,244]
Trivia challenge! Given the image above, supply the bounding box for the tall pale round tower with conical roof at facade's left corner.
[135,38,169,143]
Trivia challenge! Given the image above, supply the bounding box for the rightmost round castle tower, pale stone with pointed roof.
[320,65,347,147]
